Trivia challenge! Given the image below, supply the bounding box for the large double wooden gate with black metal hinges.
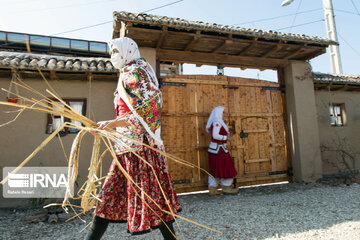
[162,75,290,192]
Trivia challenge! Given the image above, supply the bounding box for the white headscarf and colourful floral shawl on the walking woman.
[108,37,163,145]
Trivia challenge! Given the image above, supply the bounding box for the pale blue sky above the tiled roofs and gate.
[0,0,360,80]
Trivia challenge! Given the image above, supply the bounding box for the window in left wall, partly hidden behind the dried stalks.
[46,99,86,136]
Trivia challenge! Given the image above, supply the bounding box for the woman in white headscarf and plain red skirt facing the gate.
[206,106,238,195]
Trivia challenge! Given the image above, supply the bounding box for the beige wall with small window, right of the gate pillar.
[315,90,360,175]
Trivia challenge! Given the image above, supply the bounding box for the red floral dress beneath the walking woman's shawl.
[95,58,181,234]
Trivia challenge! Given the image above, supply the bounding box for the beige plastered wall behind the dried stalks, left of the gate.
[0,74,117,207]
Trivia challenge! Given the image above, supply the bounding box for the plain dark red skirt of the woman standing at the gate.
[209,148,237,179]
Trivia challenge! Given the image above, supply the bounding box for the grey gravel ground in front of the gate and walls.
[0,183,360,240]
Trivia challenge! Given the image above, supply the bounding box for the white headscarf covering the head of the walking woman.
[108,37,140,69]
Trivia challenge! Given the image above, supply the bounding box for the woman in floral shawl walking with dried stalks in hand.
[87,37,181,240]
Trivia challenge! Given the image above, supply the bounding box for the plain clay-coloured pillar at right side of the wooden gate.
[284,61,322,182]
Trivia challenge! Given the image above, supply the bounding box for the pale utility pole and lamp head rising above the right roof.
[281,0,343,75]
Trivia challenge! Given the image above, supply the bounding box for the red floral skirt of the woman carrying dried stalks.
[95,139,181,234]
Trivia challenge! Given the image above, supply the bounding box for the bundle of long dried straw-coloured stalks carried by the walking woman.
[0,79,220,236]
